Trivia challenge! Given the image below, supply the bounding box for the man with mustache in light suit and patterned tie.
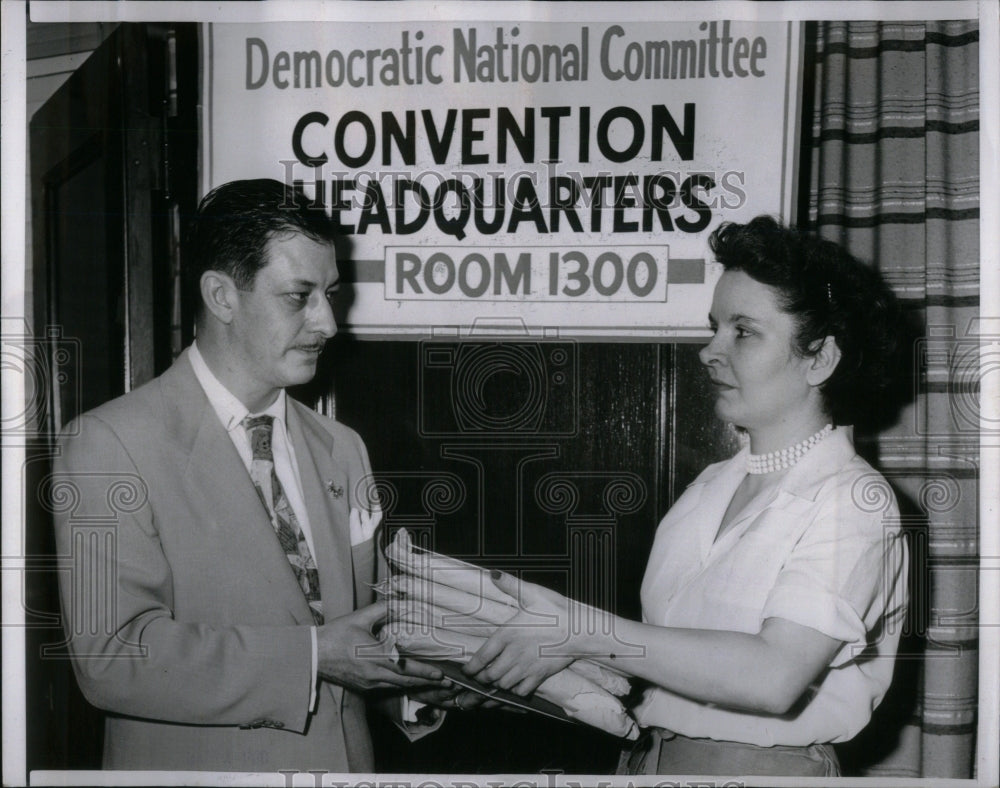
[49,181,447,772]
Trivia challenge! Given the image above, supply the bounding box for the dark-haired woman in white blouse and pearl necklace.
[466,217,906,776]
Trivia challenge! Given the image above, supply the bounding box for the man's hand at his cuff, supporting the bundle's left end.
[316,603,444,691]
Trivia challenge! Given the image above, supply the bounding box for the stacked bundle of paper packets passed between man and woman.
[381,529,638,739]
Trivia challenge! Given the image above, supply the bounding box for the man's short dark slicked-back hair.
[185,178,335,314]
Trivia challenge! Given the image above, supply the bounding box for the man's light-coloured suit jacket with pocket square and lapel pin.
[50,353,377,772]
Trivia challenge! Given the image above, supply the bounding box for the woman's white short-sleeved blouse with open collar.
[636,428,907,746]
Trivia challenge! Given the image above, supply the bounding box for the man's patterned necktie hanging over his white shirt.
[243,416,323,624]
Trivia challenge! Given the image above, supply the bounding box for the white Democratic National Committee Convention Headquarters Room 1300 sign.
[201,13,800,339]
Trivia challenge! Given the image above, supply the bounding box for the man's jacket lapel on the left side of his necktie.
[161,354,312,624]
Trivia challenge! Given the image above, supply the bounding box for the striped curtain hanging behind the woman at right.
[802,21,980,778]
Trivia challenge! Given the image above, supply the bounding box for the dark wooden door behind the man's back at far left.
[25,20,198,769]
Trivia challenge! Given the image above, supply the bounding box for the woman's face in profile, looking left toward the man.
[699,271,818,438]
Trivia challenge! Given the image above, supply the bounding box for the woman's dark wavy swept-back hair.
[709,216,901,424]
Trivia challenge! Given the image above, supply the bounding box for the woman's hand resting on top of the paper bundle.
[462,572,583,696]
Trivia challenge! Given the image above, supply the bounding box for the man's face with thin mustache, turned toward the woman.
[230,233,339,410]
